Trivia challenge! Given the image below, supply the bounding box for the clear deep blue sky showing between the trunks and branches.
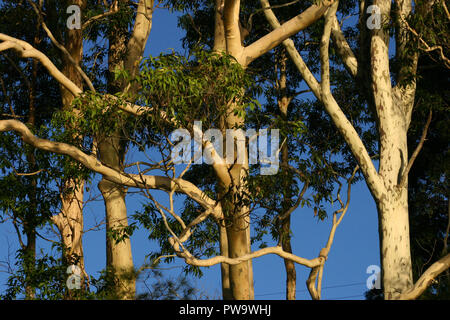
[0,6,379,300]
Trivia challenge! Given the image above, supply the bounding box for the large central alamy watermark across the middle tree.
[170,121,280,175]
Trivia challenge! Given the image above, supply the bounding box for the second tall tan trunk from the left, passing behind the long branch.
[98,0,154,299]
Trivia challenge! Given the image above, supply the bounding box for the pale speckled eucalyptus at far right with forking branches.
[261,0,450,299]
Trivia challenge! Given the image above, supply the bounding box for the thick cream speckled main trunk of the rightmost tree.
[370,0,418,300]
